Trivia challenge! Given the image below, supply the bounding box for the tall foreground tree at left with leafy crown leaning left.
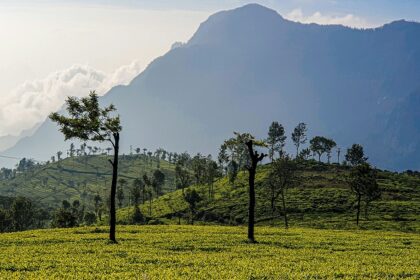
[50,92,122,243]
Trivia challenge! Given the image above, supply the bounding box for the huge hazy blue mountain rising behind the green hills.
[1,4,420,170]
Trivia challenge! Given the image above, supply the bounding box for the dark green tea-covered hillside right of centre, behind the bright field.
[119,162,420,232]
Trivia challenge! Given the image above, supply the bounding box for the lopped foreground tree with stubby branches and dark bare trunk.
[245,137,266,243]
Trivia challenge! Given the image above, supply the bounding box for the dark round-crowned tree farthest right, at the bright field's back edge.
[349,163,380,225]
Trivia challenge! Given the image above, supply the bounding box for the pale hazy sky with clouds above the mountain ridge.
[0,0,420,136]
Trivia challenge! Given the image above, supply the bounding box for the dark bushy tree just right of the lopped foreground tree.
[267,157,299,228]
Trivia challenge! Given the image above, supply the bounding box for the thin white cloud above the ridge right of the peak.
[285,9,375,28]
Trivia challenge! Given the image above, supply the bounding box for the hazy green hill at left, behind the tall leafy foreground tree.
[0,155,174,207]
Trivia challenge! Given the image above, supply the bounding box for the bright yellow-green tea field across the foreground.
[0,226,420,279]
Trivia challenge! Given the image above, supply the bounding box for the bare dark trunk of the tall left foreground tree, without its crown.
[109,133,120,243]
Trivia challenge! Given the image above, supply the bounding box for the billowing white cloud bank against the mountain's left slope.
[0,61,143,136]
